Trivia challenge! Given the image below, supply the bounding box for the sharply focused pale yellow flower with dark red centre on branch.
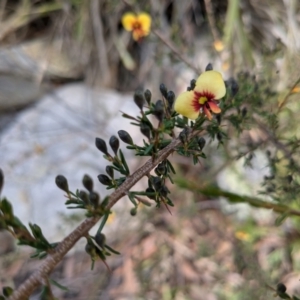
[174,71,226,120]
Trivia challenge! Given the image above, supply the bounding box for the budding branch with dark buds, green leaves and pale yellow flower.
[0,63,297,299]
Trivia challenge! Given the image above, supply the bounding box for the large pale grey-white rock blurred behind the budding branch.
[0,84,141,237]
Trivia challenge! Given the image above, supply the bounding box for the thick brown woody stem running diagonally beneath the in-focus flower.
[9,131,204,300]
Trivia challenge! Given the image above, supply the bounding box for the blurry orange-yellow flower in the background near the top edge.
[122,13,151,41]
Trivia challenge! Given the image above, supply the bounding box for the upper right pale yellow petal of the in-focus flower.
[194,71,226,100]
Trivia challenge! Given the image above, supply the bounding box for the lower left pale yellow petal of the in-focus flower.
[174,91,199,120]
